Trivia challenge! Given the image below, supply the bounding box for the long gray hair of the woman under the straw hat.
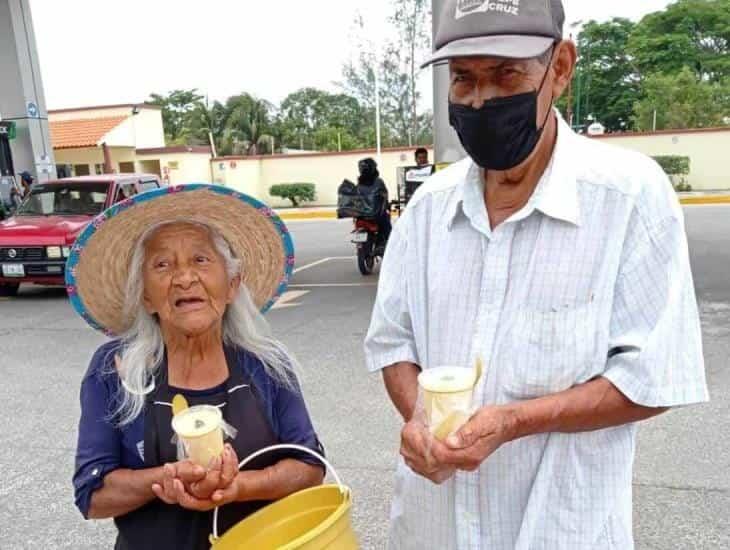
[113,220,298,426]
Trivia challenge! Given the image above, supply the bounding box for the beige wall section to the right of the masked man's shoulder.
[596,130,730,191]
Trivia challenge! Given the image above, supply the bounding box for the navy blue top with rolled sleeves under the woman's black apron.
[73,340,321,517]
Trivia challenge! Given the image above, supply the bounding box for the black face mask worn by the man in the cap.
[449,55,552,172]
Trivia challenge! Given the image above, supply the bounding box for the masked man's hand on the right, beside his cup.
[432,407,513,472]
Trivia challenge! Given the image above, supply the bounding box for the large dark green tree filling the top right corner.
[629,0,730,82]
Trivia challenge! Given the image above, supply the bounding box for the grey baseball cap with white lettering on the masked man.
[422,0,565,67]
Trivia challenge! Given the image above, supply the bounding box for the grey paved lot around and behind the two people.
[0,206,730,550]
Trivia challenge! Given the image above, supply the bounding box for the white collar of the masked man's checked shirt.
[448,109,580,230]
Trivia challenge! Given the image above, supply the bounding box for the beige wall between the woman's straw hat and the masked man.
[212,147,433,207]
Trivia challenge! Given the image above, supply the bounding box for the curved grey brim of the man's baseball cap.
[421,35,556,68]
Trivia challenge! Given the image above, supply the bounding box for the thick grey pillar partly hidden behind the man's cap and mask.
[431,0,466,164]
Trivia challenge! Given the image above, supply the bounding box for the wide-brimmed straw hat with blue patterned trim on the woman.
[66,184,294,336]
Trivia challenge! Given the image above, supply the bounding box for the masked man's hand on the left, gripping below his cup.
[400,419,456,485]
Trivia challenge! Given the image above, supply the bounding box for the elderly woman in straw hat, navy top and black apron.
[67,185,324,550]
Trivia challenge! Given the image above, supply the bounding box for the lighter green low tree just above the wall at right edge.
[634,67,730,131]
